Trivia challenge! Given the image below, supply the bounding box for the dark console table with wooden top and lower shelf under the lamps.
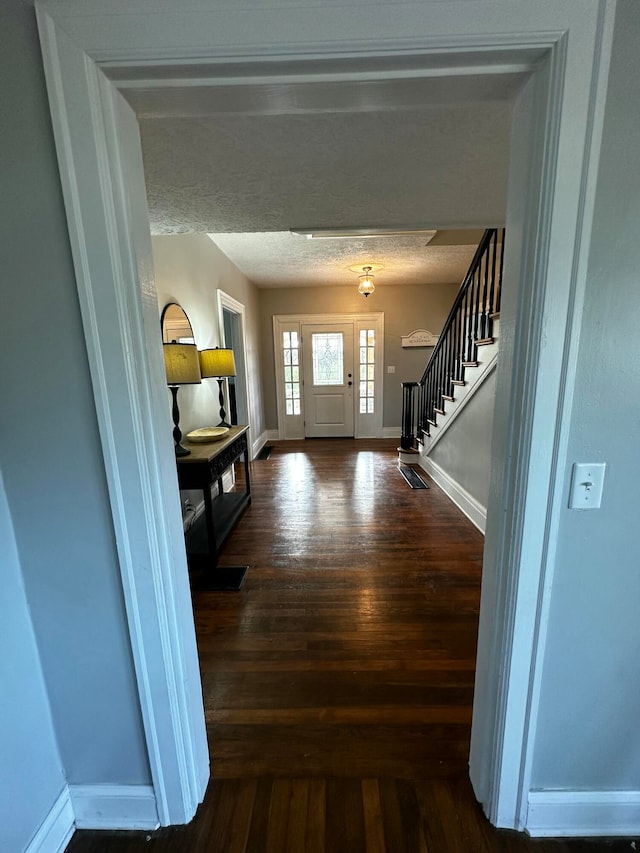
[176,426,251,590]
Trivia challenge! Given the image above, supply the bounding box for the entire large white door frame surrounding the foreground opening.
[37,0,615,828]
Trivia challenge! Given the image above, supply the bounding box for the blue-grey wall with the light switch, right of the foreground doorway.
[532,0,640,791]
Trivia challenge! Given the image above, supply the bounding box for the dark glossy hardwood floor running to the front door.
[68,439,630,853]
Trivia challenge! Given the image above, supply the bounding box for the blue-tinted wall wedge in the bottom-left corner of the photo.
[0,476,65,851]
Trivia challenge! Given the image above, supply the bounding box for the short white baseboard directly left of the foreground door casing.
[69,785,160,829]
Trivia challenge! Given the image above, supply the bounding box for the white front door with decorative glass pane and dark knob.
[302,323,354,438]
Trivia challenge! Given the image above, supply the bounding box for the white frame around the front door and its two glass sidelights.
[273,311,384,440]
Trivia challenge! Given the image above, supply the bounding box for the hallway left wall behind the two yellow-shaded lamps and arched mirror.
[151,234,265,441]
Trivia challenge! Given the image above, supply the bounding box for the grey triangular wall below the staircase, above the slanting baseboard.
[427,371,496,509]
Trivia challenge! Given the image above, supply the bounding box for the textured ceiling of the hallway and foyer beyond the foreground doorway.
[140,75,511,287]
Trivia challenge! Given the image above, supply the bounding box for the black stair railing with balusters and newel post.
[400,228,504,450]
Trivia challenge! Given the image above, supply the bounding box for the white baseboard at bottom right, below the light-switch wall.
[525,791,640,838]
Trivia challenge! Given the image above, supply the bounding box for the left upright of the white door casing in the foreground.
[37,6,209,825]
